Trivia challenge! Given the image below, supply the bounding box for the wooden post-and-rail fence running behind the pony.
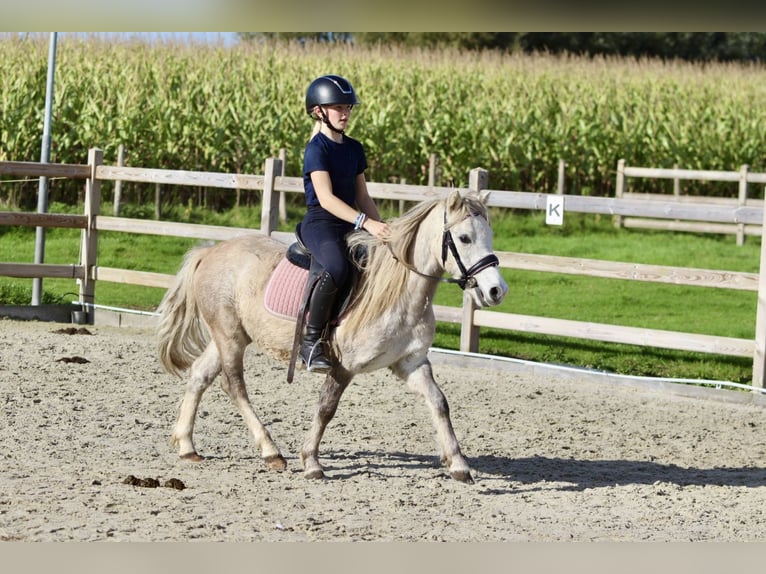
[0,149,766,388]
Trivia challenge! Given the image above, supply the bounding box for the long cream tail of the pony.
[157,246,209,378]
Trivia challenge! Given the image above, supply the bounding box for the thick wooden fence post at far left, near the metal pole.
[79,148,104,325]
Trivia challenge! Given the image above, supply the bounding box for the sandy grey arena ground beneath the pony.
[0,319,766,542]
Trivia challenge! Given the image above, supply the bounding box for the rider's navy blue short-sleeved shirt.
[303,132,367,206]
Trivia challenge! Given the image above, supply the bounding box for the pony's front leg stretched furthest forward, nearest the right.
[392,359,473,484]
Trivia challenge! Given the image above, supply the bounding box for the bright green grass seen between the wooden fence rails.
[0,206,760,384]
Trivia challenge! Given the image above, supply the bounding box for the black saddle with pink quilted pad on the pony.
[264,223,363,383]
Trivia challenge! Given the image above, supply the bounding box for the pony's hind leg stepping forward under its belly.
[220,335,287,470]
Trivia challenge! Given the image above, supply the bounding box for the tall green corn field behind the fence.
[0,35,766,210]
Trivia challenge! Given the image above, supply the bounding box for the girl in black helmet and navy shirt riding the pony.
[300,75,390,373]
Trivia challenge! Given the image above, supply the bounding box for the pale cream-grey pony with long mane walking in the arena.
[157,190,508,483]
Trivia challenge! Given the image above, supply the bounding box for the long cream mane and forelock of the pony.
[344,190,489,332]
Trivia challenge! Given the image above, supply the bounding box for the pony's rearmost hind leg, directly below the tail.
[171,341,221,461]
